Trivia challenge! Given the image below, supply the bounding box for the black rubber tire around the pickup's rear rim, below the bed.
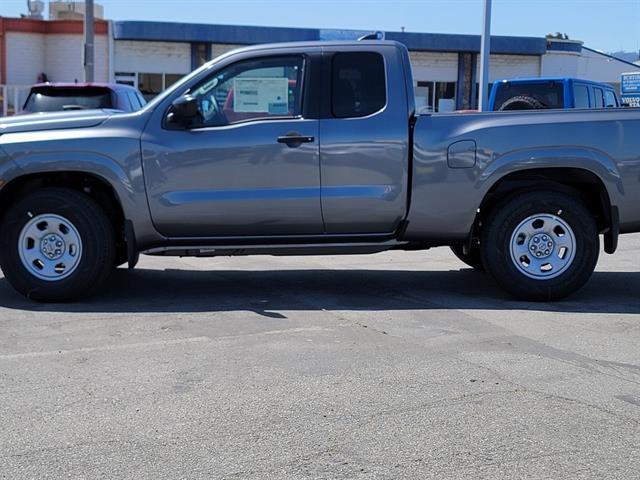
[481,191,600,301]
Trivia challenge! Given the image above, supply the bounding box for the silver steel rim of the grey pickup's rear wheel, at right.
[510,214,576,280]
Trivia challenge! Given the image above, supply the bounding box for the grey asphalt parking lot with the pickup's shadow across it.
[0,235,640,480]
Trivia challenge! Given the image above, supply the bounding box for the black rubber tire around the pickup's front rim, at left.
[0,188,115,302]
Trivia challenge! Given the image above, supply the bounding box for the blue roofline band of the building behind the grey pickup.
[114,21,547,55]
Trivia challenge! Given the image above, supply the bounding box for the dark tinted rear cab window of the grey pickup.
[331,52,387,118]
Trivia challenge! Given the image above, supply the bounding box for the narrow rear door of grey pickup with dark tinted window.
[320,44,413,234]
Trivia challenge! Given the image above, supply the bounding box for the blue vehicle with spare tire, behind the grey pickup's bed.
[489,77,620,111]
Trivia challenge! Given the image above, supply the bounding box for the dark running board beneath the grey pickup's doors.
[141,240,408,257]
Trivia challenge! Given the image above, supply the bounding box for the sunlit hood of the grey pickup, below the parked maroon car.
[0,110,112,135]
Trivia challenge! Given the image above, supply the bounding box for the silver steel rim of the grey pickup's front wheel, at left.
[18,214,82,282]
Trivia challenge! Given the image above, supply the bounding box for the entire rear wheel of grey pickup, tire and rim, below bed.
[481,191,600,301]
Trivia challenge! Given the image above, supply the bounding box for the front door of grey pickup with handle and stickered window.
[142,50,323,237]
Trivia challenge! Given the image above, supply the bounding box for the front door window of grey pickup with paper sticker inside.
[192,56,304,127]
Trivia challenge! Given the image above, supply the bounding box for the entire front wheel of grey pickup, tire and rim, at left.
[0,188,115,302]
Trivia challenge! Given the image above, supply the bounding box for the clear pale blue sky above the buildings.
[0,0,640,52]
